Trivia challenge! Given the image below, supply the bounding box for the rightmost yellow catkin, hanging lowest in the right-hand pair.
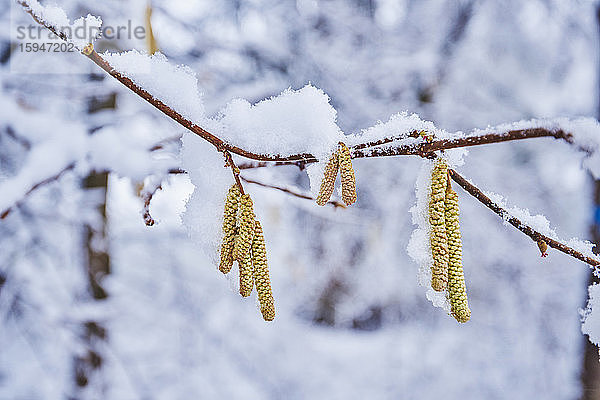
[445,185,471,322]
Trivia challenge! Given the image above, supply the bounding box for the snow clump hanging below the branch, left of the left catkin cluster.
[182,132,234,265]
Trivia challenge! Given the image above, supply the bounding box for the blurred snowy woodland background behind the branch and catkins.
[0,0,600,400]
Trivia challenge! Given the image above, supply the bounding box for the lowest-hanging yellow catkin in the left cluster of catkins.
[252,221,275,321]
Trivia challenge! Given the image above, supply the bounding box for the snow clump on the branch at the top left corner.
[27,0,102,50]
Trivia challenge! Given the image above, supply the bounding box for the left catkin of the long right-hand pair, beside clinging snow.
[429,159,448,292]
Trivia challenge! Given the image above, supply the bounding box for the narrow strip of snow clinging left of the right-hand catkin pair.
[406,160,450,312]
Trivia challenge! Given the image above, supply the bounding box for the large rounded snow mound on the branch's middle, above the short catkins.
[217,85,345,161]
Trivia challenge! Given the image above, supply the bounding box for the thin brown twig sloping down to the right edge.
[448,169,600,267]
